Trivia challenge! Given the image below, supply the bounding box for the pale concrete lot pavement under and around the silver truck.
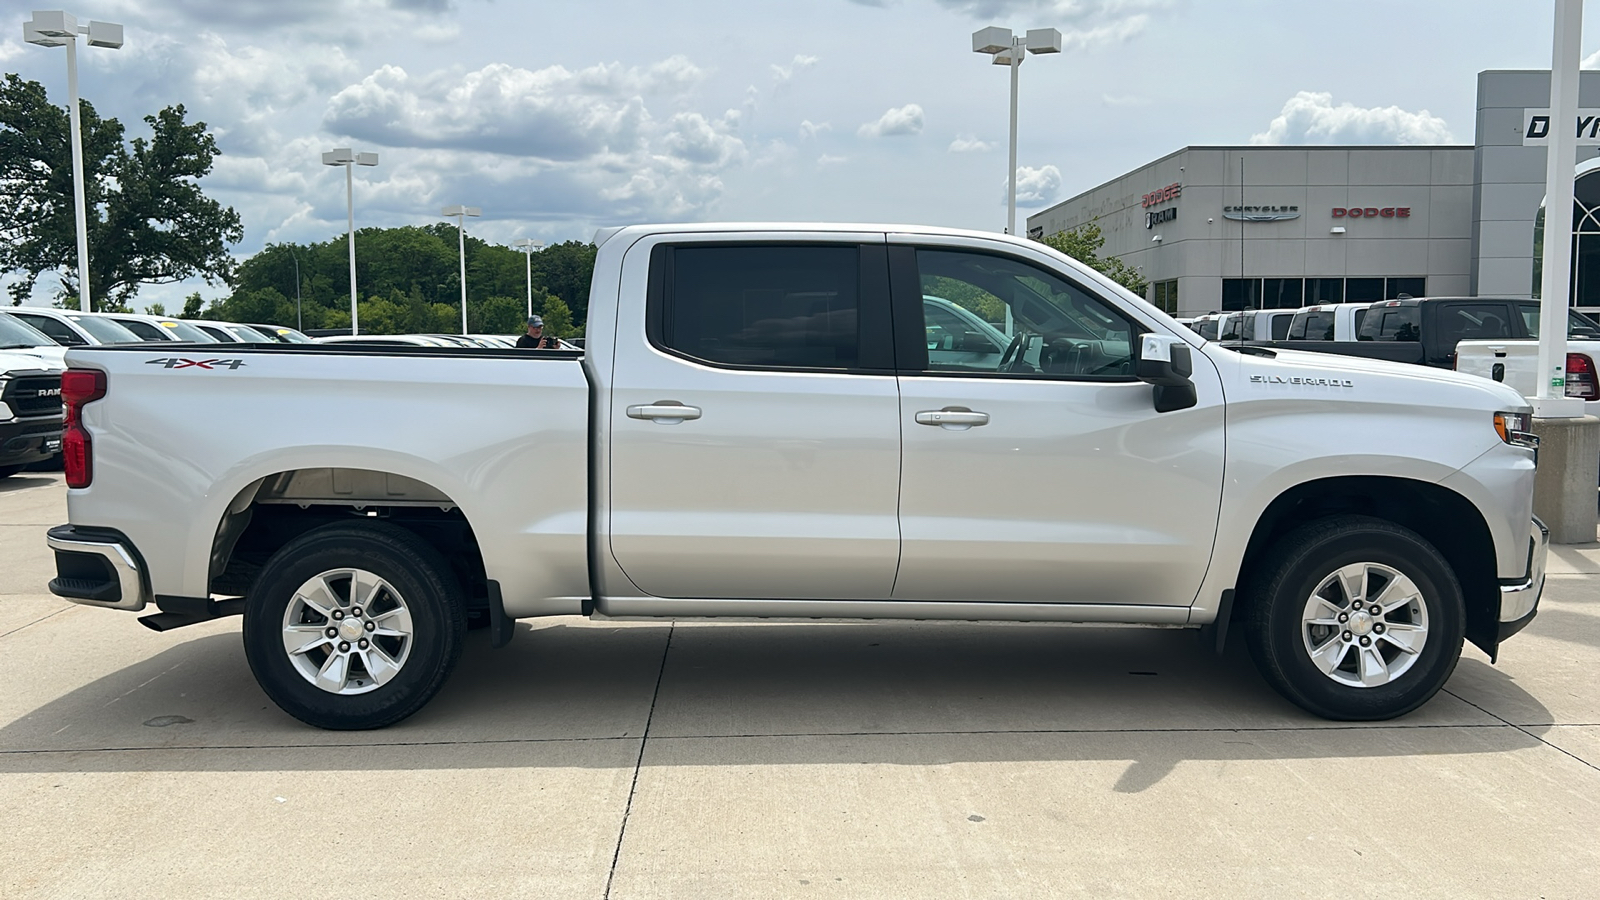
[0,472,1600,898]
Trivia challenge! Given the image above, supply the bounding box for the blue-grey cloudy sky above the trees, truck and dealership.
[0,0,1600,304]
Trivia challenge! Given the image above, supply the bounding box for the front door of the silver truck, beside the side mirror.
[890,235,1224,607]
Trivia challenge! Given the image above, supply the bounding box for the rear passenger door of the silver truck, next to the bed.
[608,234,901,599]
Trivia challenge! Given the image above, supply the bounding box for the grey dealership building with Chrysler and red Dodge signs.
[1027,70,1600,315]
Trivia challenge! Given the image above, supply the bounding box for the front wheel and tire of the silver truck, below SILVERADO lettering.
[1245,516,1466,721]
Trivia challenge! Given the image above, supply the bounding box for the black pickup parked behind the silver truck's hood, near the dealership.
[1226,296,1600,368]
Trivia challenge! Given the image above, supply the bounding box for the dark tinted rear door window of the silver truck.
[659,245,861,368]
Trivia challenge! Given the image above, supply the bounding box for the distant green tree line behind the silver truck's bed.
[219,223,595,338]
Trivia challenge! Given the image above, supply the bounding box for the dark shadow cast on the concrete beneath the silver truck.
[0,620,1539,781]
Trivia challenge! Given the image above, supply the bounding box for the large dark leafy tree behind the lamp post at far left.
[0,74,243,309]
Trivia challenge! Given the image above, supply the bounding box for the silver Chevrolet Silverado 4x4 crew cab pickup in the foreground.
[48,224,1547,729]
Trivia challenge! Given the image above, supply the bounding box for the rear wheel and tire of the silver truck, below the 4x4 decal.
[243,522,467,730]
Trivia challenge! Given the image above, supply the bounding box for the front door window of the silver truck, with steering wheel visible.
[917,250,1139,380]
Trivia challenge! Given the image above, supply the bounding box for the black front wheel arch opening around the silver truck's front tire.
[1234,476,1499,658]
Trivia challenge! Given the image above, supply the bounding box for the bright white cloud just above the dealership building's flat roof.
[1250,91,1454,144]
